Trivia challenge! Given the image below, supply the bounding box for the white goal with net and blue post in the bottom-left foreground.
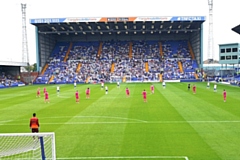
[0,133,56,160]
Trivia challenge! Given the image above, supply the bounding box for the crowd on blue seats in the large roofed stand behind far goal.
[34,41,202,83]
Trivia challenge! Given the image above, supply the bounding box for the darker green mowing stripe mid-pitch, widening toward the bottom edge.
[122,84,218,158]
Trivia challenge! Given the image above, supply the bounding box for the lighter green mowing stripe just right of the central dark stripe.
[162,83,240,159]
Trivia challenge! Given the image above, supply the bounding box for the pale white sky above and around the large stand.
[0,0,240,64]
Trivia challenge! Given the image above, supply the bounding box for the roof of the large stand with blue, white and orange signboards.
[30,16,205,35]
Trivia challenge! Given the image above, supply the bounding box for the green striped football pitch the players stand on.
[0,82,240,160]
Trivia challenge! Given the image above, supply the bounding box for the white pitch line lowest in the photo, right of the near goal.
[57,156,189,160]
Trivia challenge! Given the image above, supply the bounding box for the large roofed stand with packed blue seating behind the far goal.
[30,16,205,83]
